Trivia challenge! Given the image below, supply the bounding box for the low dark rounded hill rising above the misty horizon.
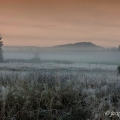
[53,42,105,50]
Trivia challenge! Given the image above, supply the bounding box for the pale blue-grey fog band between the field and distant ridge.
[4,51,120,64]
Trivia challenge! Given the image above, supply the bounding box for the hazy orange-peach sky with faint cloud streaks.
[0,0,120,47]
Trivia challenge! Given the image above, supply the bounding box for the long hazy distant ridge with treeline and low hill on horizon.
[3,42,106,52]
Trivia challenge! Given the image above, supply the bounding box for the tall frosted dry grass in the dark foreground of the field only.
[0,72,120,120]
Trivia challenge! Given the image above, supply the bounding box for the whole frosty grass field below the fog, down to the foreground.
[0,63,120,120]
